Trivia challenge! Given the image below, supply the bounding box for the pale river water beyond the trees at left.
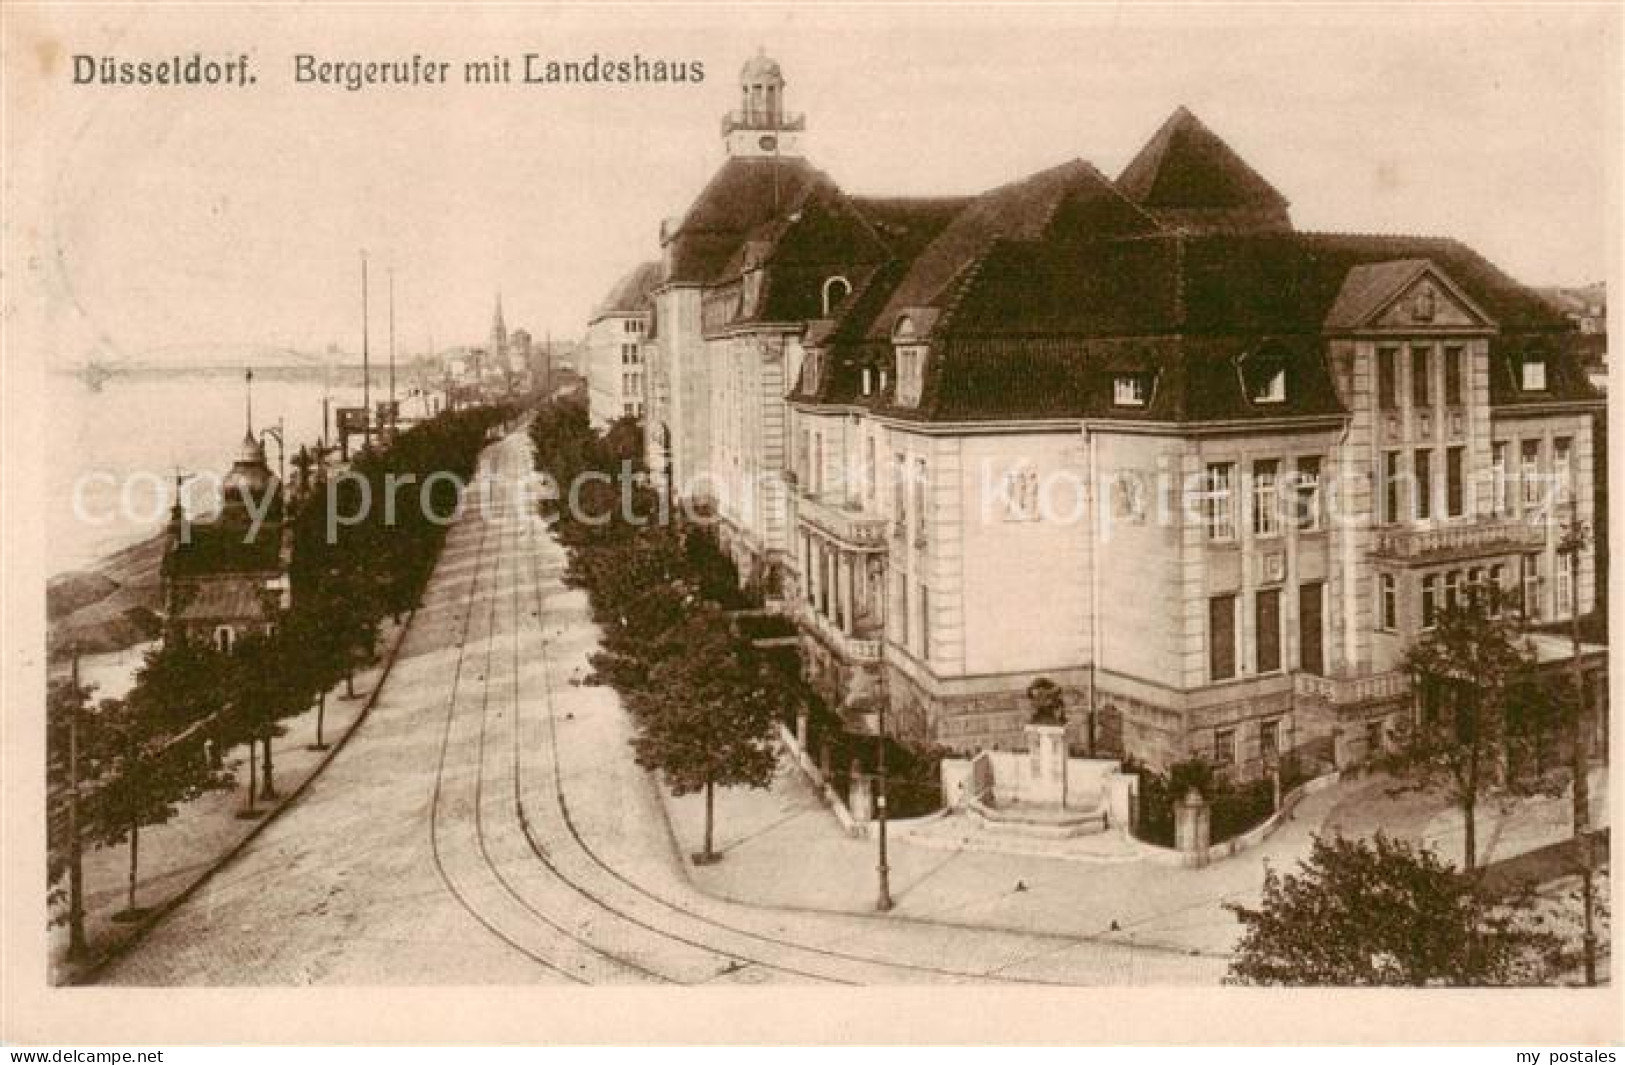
[46,369,432,572]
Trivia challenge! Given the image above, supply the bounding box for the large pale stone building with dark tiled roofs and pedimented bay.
[630,54,1602,774]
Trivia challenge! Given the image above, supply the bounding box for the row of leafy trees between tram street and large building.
[531,400,804,863]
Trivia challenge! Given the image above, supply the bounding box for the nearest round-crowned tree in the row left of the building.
[629,605,778,863]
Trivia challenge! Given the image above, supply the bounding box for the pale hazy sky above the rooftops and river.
[8,5,1620,364]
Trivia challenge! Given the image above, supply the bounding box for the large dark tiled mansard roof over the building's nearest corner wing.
[798,229,1596,421]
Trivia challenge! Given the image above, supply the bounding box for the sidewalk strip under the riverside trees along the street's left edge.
[49,618,410,984]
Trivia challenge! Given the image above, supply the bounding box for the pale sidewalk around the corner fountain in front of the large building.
[661,751,1607,954]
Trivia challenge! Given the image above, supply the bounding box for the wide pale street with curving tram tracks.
[104,436,1224,985]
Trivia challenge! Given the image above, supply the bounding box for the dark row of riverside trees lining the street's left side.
[47,406,512,958]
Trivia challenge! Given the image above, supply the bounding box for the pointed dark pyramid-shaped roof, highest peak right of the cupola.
[1116,107,1290,228]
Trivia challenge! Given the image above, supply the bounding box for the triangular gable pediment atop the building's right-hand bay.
[1326,259,1495,333]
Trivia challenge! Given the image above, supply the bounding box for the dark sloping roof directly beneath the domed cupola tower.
[665,156,834,285]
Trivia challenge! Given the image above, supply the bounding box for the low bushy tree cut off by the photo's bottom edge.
[1225,832,1547,987]
